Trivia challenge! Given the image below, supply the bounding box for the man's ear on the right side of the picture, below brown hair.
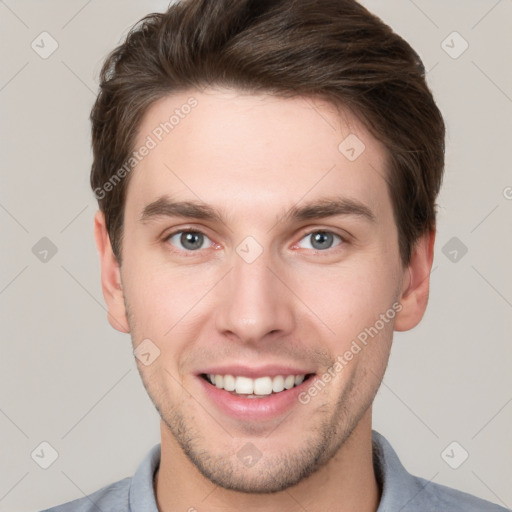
[395,229,436,331]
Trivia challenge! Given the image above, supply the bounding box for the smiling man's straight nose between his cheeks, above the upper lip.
[215,247,295,344]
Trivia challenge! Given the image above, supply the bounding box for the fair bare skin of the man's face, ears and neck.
[95,88,435,512]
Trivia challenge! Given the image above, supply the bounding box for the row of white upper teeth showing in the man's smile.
[207,373,306,395]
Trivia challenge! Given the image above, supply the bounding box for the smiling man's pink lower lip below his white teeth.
[197,375,315,420]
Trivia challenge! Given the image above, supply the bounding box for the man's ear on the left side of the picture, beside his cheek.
[94,211,130,333]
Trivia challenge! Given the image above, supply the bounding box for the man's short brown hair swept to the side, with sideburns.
[91,0,445,265]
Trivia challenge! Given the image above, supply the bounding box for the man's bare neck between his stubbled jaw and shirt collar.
[155,409,380,512]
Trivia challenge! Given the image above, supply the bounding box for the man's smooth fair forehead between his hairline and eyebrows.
[126,89,390,222]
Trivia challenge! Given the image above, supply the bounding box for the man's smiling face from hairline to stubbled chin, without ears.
[95,89,428,492]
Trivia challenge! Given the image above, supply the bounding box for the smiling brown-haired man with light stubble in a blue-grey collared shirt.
[42,0,504,512]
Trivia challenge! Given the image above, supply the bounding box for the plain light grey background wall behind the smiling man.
[0,0,512,512]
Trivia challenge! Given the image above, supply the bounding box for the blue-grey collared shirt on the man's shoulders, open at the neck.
[42,430,507,512]
